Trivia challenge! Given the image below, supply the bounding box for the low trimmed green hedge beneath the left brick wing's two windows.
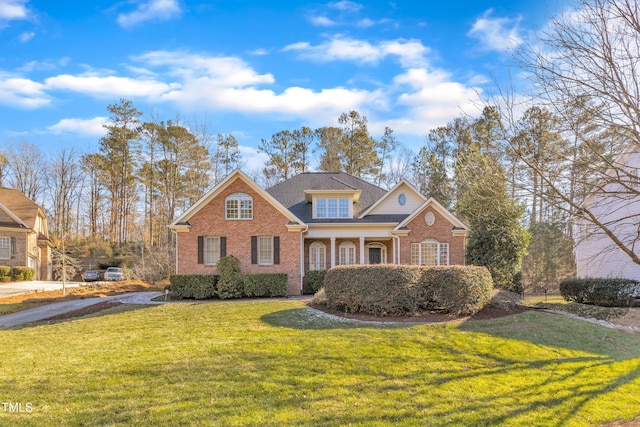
[169,273,288,299]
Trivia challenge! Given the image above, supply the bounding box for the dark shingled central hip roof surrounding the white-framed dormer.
[266,172,388,223]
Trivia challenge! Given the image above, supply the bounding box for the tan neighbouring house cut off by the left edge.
[0,188,53,280]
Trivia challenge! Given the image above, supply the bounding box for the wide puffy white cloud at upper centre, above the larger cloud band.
[283,36,429,67]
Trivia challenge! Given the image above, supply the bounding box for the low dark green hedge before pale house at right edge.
[560,278,640,307]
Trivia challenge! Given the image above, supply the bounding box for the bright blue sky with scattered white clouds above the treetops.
[0,0,562,171]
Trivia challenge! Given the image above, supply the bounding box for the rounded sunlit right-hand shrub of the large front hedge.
[417,266,493,315]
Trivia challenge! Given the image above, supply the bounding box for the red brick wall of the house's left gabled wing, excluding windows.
[177,179,301,295]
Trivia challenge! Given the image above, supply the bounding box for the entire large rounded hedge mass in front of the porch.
[324,265,493,316]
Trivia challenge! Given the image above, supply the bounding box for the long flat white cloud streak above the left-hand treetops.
[45,74,179,98]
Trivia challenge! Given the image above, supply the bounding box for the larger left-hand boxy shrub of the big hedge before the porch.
[324,265,420,316]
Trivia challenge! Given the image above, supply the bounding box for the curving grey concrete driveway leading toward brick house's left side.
[0,292,163,328]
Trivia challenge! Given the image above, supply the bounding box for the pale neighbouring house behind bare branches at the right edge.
[574,144,640,280]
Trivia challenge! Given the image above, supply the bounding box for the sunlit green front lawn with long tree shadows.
[0,300,640,426]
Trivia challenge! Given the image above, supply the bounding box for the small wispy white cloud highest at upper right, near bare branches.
[467,9,523,52]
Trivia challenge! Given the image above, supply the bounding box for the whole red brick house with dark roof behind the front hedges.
[169,170,469,295]
